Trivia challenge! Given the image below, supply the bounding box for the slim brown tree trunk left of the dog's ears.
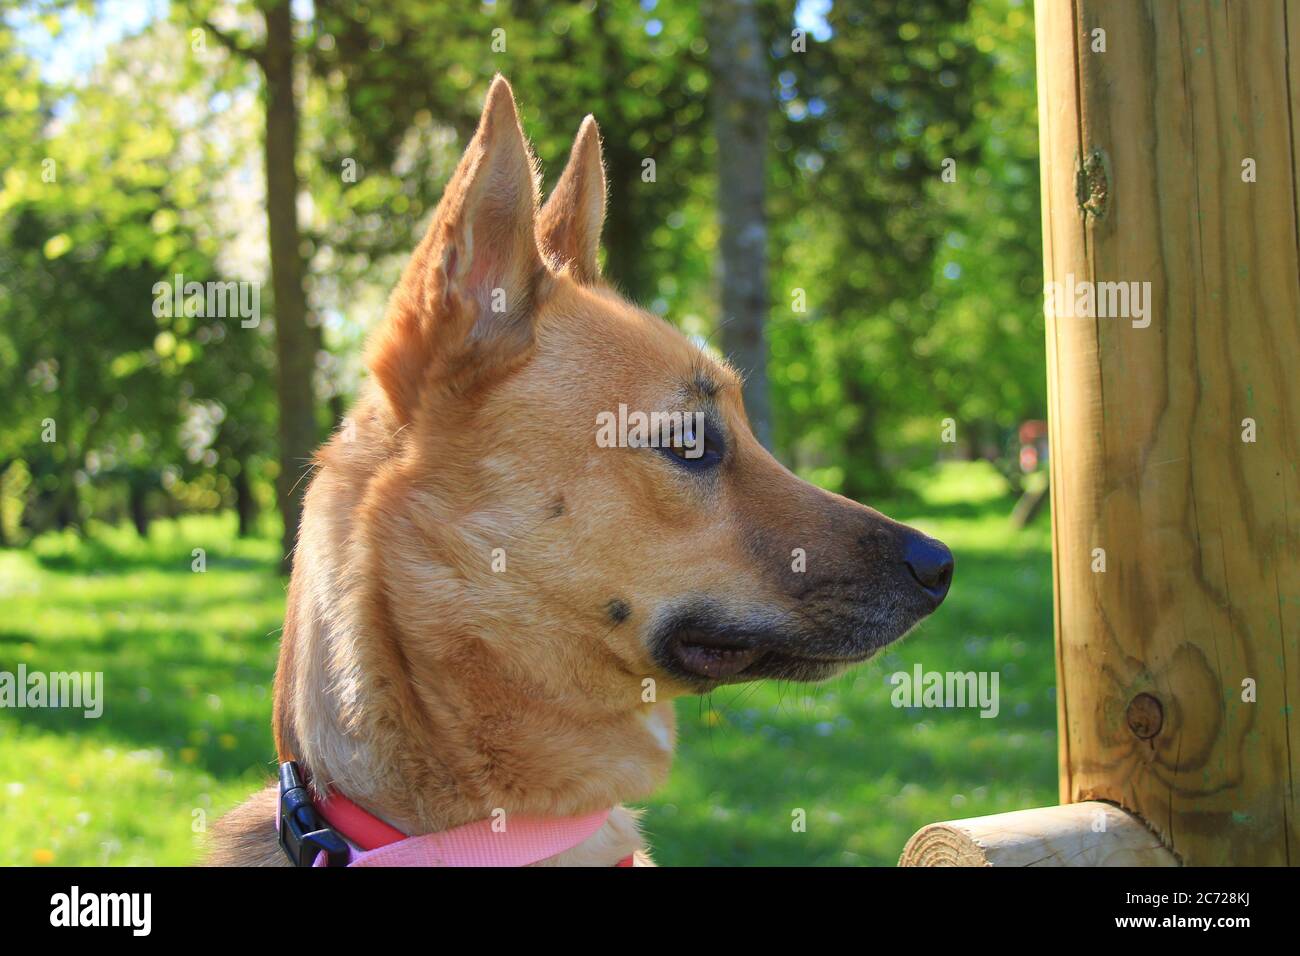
[263,0,316,574]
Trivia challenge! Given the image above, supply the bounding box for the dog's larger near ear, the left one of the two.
[368,75,546,419]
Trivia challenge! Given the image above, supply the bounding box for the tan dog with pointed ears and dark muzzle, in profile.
[209,77,953,866]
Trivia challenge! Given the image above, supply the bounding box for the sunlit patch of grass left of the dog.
[0,515,285,865]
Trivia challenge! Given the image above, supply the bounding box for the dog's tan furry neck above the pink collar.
[276,421,675,834]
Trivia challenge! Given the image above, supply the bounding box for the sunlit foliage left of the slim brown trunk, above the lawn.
[0,11,274,538]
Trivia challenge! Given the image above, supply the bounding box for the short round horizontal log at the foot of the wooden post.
[898,801,1178,866]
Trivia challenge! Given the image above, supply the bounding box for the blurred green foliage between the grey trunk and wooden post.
[770,0,1045,498]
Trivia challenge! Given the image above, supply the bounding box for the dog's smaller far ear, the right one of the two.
[537,116,605,284]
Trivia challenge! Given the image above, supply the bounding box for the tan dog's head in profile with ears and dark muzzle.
[360,78,953,693]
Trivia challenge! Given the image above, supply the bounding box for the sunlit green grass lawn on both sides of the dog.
[0,466,1056,865]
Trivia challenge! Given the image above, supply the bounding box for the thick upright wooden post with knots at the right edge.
[1035,0,1300,865]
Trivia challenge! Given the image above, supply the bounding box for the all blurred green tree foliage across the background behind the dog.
[0,0,1045,527]
